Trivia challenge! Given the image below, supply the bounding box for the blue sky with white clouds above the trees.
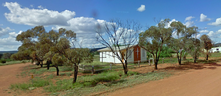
[0,0,221,51]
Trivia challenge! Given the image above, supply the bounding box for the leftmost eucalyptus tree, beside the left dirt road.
[12,26,46,67]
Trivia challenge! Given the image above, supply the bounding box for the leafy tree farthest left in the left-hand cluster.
[13,26,47,67]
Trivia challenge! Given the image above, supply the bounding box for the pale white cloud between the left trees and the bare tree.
[52,17,106,47]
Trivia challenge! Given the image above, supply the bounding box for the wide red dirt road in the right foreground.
[106,62,221,96]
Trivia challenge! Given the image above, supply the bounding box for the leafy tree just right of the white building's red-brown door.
[139,19,172,69]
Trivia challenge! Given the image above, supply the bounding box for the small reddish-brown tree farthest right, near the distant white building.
[200,34,213,60]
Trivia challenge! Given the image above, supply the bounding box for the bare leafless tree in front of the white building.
[96,20,141,74]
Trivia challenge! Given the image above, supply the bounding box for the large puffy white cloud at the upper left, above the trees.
[4,2,75,26]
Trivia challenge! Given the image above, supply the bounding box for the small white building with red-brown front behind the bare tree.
[98,45,147,63]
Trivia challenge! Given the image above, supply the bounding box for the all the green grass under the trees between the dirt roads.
[10,55,200,96]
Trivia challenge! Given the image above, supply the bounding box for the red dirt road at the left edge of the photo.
[0,63,30,96]
